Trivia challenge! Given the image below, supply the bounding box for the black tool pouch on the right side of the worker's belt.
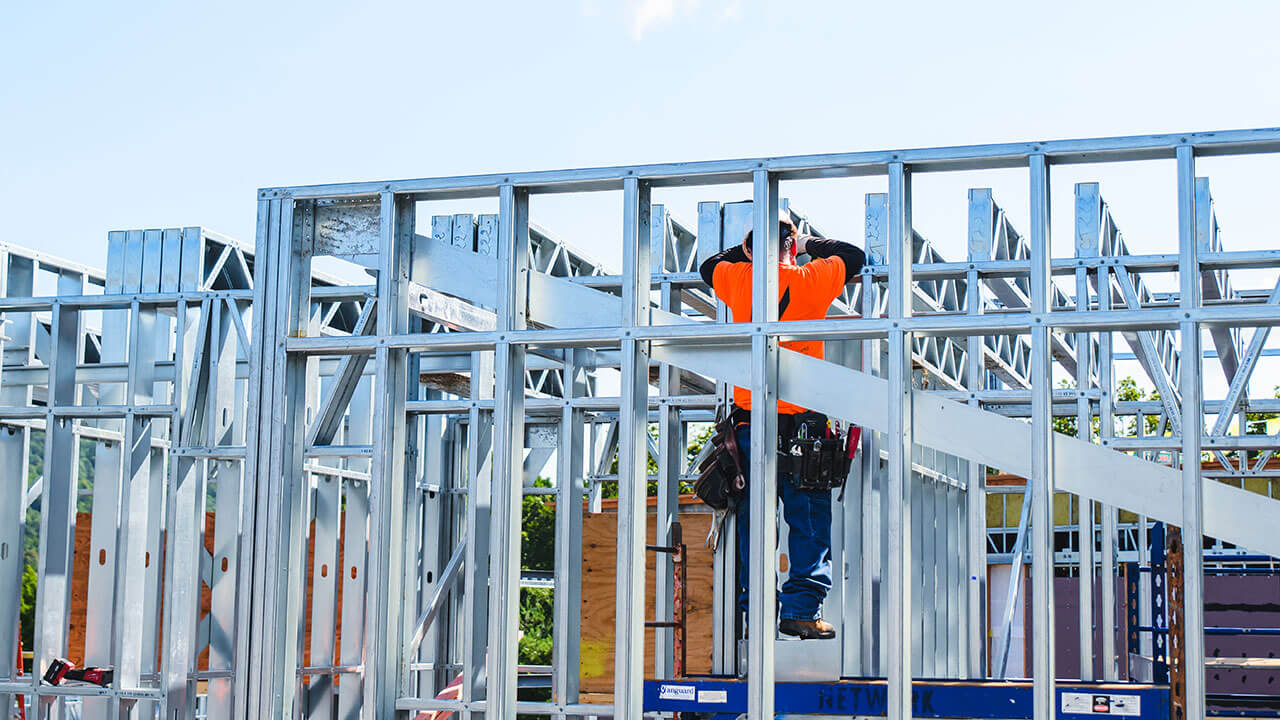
[778,413,861,492]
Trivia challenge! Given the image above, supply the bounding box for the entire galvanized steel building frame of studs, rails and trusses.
[0,128,1280,719]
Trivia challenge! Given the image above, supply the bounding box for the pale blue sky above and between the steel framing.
[0,0,1280,404]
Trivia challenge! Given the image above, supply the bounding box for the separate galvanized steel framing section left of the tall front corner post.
[0,227,373,717]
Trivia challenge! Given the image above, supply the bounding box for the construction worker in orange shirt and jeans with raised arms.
[699,214,867,639]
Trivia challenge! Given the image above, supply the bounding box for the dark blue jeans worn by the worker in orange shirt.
[736,425,831,620]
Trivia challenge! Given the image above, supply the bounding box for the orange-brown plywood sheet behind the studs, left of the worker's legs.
[580,512,714,693]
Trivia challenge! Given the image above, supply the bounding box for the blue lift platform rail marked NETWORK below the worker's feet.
[644,678,1169,720]
